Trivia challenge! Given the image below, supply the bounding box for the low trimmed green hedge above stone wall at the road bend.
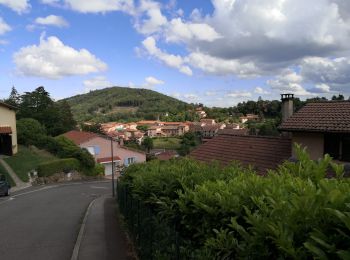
[37,158,80,177]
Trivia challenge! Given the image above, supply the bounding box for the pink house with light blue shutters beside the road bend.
[64,130,146,175]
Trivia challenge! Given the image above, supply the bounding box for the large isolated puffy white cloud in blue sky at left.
[13,36,107,79]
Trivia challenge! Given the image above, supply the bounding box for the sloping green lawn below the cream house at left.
[5,146,57,182]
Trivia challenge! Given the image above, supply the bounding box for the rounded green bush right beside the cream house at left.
[17,118,46,146]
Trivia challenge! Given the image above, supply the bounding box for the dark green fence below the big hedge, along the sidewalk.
[117,182,192,260]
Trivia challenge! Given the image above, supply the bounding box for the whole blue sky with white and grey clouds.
[0,0,350,107]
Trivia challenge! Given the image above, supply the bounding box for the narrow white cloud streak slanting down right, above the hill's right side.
[142,36,192,76]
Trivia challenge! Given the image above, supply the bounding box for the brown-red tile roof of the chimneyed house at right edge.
[279,101,350,133]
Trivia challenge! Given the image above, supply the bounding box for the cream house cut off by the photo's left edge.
[0,102,18,155]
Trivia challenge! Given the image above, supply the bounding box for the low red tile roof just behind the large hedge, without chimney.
[190,134,292,173]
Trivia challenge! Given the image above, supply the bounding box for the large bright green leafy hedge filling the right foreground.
[120,146,350,259]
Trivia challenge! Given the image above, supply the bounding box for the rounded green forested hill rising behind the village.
[59,87,193,122]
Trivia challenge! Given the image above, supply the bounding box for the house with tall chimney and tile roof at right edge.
[279,95,350,162]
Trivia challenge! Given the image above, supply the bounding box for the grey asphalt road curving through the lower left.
[0,182,118,260]
